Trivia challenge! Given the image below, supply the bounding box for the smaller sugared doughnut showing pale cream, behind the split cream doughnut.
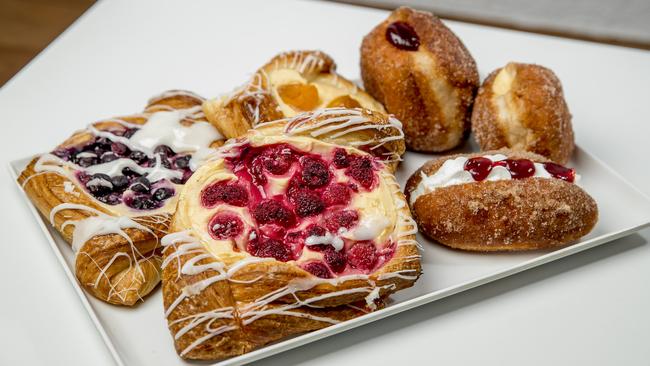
[472,62,574,164]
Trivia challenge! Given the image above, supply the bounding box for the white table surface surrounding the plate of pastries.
[0,0,650,366]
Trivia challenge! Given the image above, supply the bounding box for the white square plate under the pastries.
[10,144,650,366]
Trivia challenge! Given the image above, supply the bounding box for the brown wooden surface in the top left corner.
[0,0,94,86]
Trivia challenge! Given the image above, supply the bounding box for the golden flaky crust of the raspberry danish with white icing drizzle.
[163,129,420,359]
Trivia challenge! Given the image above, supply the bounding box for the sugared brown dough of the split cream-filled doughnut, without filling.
[406,150,598,252]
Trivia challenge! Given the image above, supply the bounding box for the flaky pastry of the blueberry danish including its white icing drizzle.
[18,90,223,305]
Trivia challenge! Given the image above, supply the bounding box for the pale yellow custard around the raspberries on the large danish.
[177,133,398,262]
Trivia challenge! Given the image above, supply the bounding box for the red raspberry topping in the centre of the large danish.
[200,144,395,278]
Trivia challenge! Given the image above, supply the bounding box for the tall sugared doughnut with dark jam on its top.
[361,7,479,152]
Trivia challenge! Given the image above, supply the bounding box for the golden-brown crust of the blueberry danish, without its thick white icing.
[18,91,223,306]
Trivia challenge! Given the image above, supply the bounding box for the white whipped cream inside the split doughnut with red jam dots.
[410,154,579,205]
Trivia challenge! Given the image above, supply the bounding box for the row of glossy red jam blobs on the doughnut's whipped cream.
[464,156,576,183]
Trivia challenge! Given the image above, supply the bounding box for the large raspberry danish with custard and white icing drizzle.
[162,112,420,359]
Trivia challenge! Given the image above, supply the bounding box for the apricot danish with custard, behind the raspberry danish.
[203,51,385,138]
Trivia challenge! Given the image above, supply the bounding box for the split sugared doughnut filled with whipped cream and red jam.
[406,149,598,252]
